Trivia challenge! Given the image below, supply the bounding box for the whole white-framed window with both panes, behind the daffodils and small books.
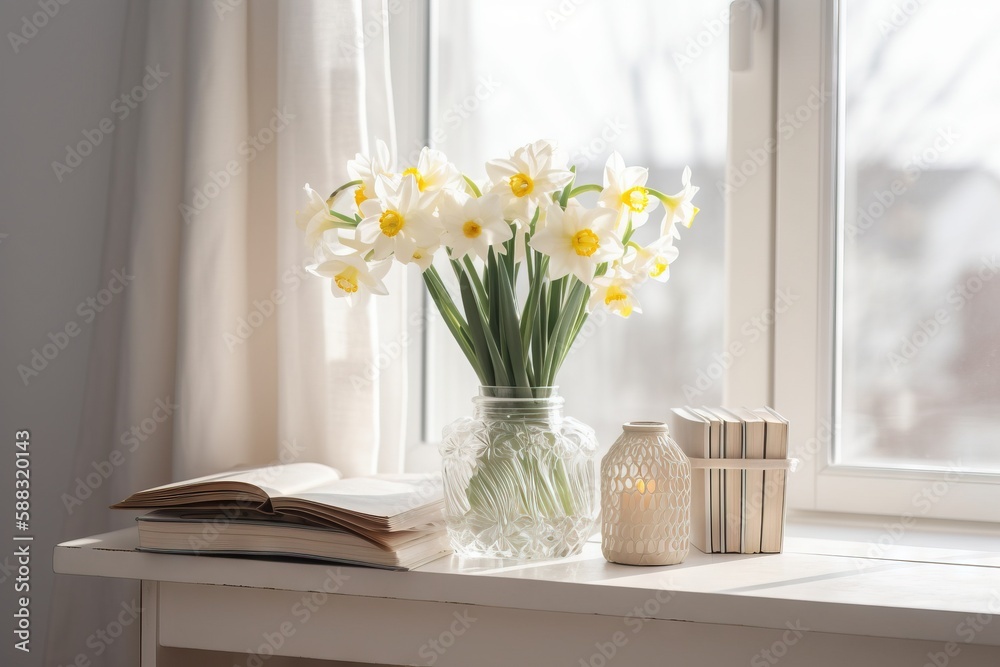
[400,0,1000,521]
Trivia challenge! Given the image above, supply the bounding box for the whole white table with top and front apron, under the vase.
[54,529,1000,667]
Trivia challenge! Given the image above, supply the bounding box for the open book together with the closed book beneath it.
[112,463,450,570]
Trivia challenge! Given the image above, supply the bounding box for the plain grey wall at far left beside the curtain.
[0,0,128,665]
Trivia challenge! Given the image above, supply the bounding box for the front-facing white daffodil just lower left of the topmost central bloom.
[438,193,513,260]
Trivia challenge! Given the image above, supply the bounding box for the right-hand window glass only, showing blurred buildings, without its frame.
[837,0,1000,471]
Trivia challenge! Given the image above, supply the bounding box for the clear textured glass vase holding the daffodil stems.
[441,387,599,559]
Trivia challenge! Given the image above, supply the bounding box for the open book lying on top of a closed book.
[112,463,444,534]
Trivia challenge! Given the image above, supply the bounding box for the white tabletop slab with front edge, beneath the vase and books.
[54,524,1000,646]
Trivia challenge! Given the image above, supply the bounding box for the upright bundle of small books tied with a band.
[671,407,788,554]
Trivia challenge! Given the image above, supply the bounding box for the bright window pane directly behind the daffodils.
[427,0,729,446]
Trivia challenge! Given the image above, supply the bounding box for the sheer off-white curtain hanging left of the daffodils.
[45,0,407,665]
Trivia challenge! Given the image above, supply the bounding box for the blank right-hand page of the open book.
[271,474,444,517]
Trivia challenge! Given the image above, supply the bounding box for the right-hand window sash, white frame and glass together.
[775,0,1000,521]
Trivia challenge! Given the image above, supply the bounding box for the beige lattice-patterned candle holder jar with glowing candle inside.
[601,422,691,565]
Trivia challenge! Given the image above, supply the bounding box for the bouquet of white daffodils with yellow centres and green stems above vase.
[297,141,698,398]
